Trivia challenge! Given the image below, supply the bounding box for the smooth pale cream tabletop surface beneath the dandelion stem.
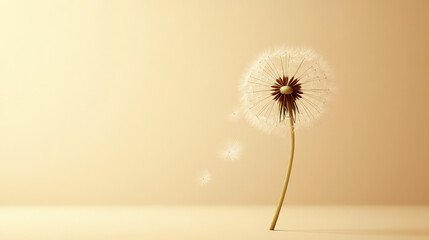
[0,206,429,240]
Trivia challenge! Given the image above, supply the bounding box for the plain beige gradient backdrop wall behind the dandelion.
[0,0,429,204]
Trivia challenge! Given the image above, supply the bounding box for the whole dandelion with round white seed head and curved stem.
[241,48,330,230]
